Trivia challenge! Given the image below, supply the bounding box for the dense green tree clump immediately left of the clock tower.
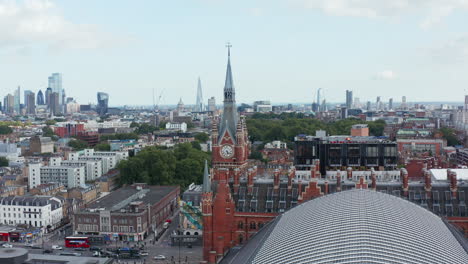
[118,143,210,188]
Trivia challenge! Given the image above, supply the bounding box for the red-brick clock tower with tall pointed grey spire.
[202,44,250,264]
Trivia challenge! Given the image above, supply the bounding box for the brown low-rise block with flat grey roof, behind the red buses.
[73,184,180,241]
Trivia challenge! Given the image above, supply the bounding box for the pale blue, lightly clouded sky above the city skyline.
[0,0,468,106]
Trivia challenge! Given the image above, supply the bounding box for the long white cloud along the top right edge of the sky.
[289,0,468,29]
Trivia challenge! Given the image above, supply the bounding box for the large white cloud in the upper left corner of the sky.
[0,0,128,51]
